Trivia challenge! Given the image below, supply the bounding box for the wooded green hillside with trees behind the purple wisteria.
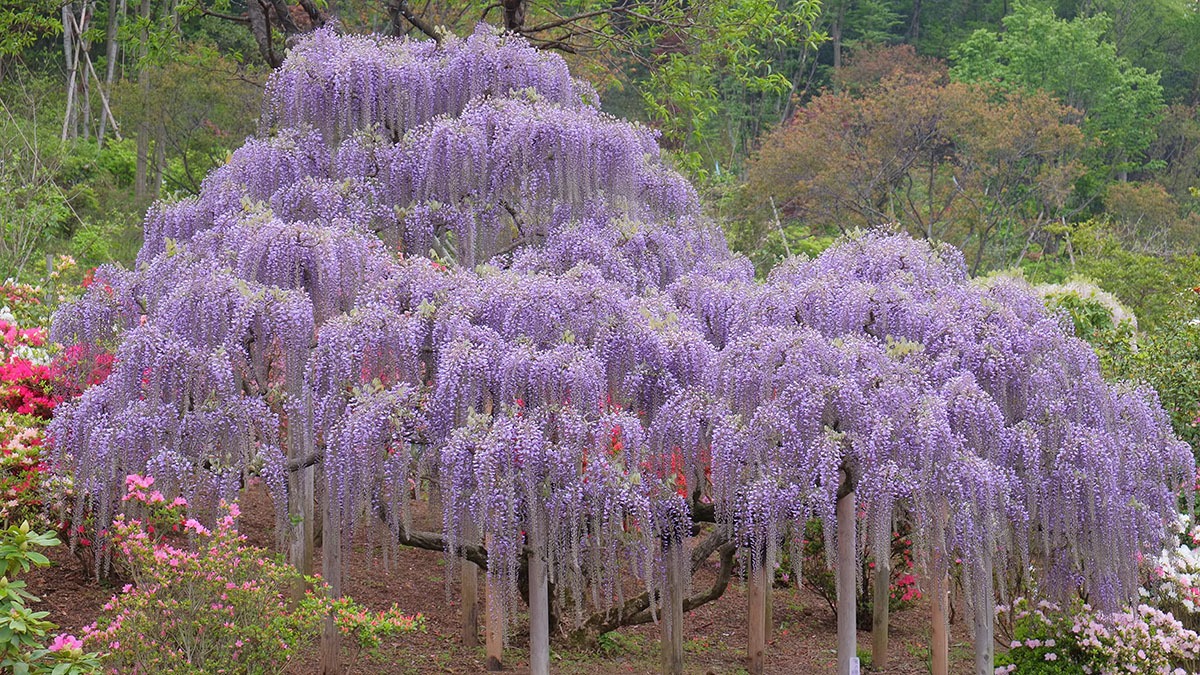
[7,0,1200,447]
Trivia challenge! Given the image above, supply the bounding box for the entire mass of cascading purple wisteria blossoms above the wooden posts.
[50,24,1194,672]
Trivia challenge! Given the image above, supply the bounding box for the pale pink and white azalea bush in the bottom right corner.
[996,598,1200,675]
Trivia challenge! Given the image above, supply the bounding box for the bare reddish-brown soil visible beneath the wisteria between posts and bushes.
[29,486,972,675]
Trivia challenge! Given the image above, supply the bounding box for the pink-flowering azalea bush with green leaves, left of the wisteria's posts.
[84,485,424,675]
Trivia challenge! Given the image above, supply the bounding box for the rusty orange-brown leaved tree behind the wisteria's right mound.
[748,48,1085,270]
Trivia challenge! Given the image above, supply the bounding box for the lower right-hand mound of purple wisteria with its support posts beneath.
[672,228,1194,673]
